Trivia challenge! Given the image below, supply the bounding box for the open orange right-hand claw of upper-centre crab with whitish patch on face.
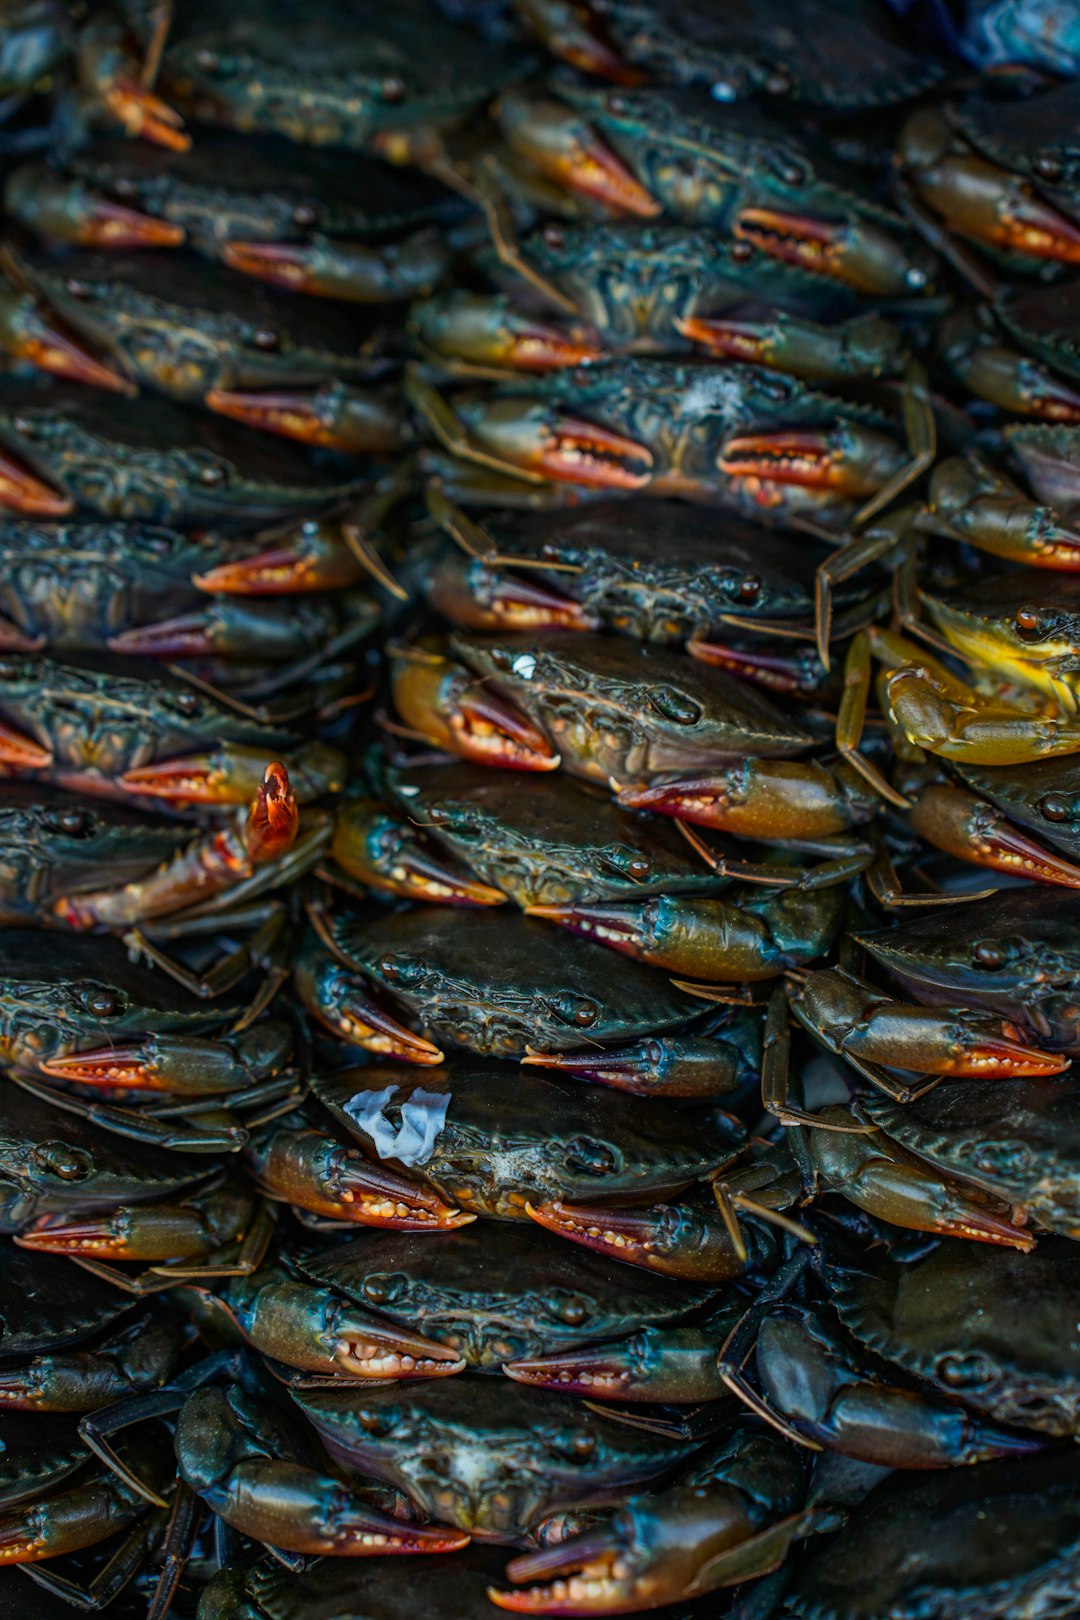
[717,423,904,499]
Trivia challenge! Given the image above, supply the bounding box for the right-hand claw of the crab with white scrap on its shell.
[526,1200,746,1283]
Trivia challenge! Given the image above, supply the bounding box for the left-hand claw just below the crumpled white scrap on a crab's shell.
[243,1126,476,1231]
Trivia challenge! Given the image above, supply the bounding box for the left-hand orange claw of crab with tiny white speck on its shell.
[392,653,559,771]
